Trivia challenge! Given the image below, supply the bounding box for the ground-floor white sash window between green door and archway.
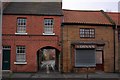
[16,46,26,62]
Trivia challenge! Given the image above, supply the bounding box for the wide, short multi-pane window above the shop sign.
[80,28,95,38]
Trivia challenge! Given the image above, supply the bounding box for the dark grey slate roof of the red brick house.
[3,2,62,15]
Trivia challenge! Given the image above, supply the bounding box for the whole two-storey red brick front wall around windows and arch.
[2,15,61,72]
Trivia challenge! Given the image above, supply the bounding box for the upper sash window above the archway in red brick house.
[44,18,54,34]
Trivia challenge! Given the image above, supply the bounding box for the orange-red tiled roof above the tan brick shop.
[63,10,112,25]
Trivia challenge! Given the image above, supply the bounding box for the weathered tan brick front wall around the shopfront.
[63,25,114,72]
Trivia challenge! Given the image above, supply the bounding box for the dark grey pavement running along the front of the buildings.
[2,72,120,80]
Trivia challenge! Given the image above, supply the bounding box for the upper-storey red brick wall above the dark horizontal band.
[3,15,61,36]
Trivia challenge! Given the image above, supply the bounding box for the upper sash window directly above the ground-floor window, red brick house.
[17,18,26,33]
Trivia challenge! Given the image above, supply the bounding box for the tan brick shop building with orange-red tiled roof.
[62,10,115,72]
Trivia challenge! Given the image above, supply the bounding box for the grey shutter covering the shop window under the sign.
[75,49,96,67]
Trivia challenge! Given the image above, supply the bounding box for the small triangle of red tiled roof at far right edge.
[107,12,120,26]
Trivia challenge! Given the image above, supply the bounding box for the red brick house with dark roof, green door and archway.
[2,2,62,72]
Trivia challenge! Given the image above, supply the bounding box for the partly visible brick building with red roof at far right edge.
[107,12,120,71]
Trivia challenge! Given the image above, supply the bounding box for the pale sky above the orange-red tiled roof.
[63,0,120,12]
